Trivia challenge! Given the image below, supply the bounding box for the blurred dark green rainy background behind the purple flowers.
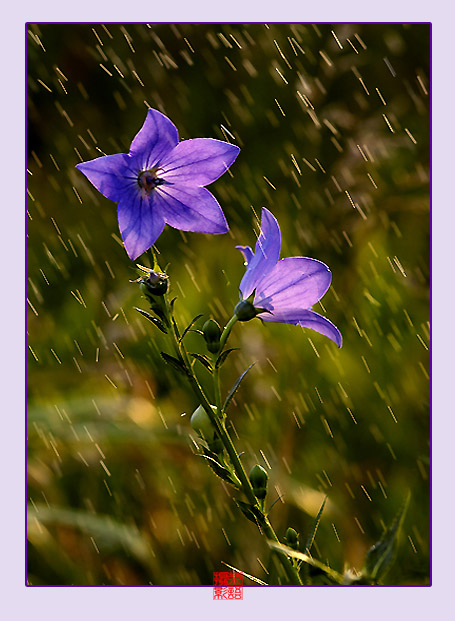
[27,24,430,585]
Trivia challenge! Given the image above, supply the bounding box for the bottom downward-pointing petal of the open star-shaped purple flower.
[118,191,164,260]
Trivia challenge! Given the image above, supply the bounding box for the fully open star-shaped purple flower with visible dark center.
[76,110,240,259]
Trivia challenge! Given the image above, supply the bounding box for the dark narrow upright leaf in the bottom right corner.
[361,492,411,583]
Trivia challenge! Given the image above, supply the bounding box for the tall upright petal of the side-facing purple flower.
[240,207,281,298]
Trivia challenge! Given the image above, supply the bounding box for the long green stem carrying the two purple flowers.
[164,296,303,585]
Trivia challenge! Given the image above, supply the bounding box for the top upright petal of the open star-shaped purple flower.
[130,109,179,170]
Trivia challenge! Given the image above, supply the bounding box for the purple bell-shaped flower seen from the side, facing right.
[234,208,343,347]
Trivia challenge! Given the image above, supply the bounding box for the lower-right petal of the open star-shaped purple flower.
[153,184,229,234]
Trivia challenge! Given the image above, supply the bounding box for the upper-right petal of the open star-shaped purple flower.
[160,138,240,186]
